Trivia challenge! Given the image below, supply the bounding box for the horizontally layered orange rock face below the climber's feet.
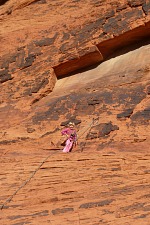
[1,144,150,225]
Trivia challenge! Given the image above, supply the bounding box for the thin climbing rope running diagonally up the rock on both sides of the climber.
[0,118,99,210]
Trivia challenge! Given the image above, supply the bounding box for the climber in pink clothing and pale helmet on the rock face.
[61,122,77,152]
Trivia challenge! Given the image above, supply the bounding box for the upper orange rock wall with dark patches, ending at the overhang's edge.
[0,0,150,102]
